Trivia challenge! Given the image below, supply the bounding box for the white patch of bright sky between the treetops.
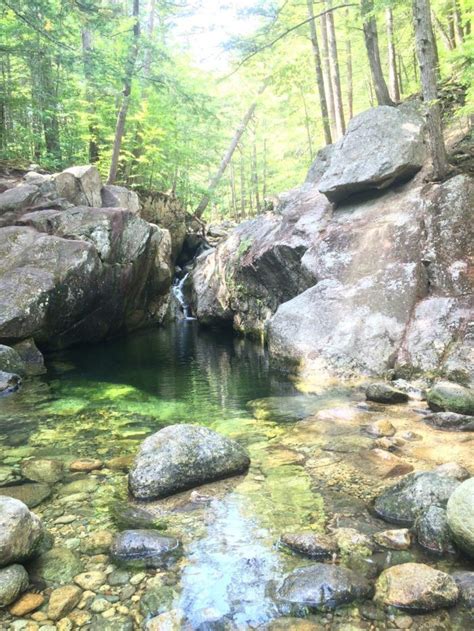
[175,0,260,71]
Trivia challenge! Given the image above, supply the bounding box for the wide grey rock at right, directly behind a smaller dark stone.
[374,472,459,526]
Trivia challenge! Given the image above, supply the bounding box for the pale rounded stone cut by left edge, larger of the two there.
[0,496,42,567]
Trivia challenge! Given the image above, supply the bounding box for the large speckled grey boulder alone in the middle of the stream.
[128,424,250,500]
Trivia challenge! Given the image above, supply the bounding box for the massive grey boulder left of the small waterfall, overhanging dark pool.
[0,207,171,348]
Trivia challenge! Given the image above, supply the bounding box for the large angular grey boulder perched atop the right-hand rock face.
[319,105,425,202]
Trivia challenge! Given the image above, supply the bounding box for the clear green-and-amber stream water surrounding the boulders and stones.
[0,321,471,630]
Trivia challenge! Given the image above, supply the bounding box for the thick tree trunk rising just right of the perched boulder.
[413,0,449,180]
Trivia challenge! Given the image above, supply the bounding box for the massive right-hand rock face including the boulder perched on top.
[191,107,474,380]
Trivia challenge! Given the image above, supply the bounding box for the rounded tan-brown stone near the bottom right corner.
[374,563,459,612]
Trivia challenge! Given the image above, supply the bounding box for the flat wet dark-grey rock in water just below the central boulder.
[110,530,180,567]
